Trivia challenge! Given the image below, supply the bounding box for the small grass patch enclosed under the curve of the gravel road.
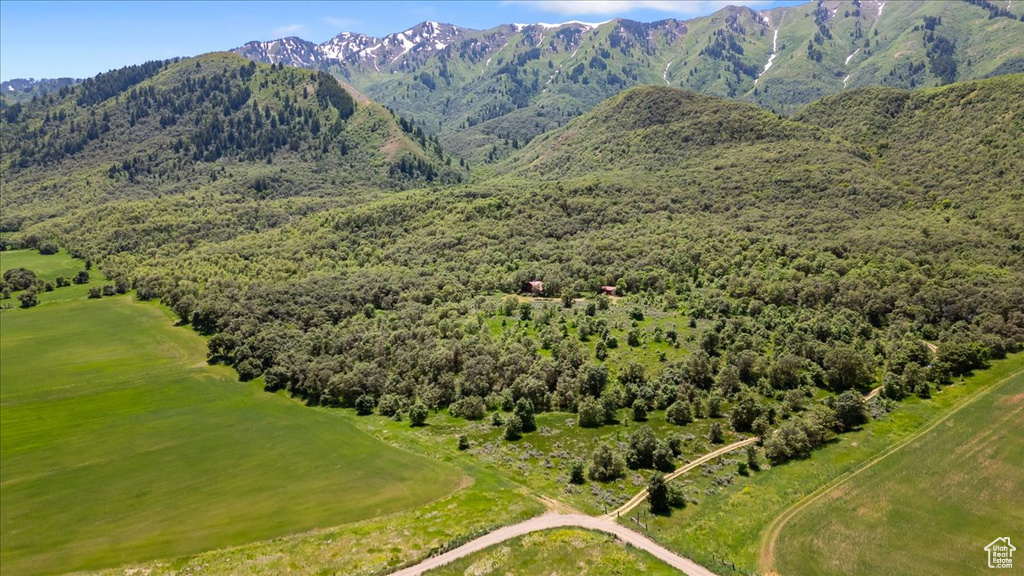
[427,529,679,576]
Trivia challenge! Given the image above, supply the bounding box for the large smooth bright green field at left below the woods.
[0,250,463,574]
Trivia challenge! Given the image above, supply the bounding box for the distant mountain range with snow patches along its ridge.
[236,0,1024,162]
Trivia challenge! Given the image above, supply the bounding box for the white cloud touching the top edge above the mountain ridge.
[504,0,771,16]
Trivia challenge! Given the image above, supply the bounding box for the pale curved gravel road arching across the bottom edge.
[392,513,715,576]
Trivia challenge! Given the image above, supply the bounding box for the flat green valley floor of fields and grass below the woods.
[0,252,1024,575]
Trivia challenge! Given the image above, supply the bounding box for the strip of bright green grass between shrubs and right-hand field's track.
[630,354,1024,574]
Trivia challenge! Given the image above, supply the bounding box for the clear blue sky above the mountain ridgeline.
[0,0,801,80]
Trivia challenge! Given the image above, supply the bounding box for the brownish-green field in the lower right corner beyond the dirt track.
[776,364,1024,575]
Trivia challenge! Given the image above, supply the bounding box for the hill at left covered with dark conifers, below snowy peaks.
[0,54,464,243]
